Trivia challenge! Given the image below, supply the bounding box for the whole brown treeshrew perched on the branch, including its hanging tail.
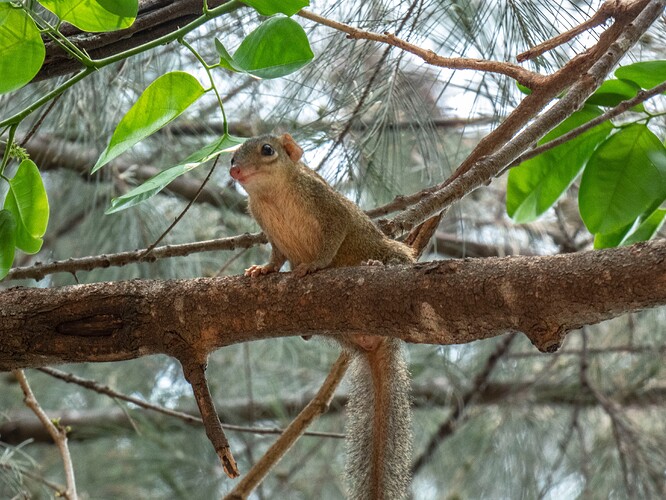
[231,134,414,500]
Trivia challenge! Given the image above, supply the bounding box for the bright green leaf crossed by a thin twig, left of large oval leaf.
[506,106,612,223]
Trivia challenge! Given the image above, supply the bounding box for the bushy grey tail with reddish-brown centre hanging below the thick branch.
[346,337,412,500]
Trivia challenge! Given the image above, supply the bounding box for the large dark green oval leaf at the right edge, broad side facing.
[578,124,666,234]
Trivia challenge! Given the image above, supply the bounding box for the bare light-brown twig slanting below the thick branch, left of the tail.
[225,352,350,500]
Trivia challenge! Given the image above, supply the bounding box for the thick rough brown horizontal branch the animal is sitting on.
[0,240,666,370]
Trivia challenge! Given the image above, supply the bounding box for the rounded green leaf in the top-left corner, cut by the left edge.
[0,3,45,94]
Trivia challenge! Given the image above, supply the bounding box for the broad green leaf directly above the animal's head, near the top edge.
[216,16,314,78]
